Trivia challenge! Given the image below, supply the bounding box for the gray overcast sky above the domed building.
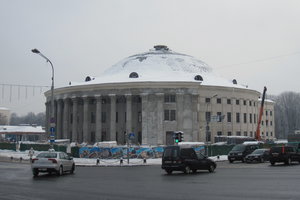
[0,0,300,114]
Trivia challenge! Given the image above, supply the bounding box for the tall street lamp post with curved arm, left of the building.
[31,49,55,149]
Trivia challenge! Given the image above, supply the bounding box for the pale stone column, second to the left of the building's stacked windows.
[141,93,149,144]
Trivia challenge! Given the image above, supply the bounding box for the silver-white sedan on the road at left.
[31,151,75,176]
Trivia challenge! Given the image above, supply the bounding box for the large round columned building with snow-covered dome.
[45,45,274,145]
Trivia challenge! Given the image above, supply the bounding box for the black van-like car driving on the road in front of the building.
[161,146,217,174]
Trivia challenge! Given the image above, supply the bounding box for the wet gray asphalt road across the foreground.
[0,162,300,200]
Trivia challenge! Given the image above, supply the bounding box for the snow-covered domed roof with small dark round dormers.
[72,45,248,87]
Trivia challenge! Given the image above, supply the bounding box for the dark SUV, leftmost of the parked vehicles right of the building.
[228,144,259,163]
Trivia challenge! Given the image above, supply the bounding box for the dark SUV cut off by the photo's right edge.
[270,146,300,165]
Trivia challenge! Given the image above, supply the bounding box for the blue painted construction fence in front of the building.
[79,146,205,159]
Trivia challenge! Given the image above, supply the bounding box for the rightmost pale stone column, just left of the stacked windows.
[156,93,166,145]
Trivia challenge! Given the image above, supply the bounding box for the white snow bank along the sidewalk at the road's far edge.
[0,150,227,166]
